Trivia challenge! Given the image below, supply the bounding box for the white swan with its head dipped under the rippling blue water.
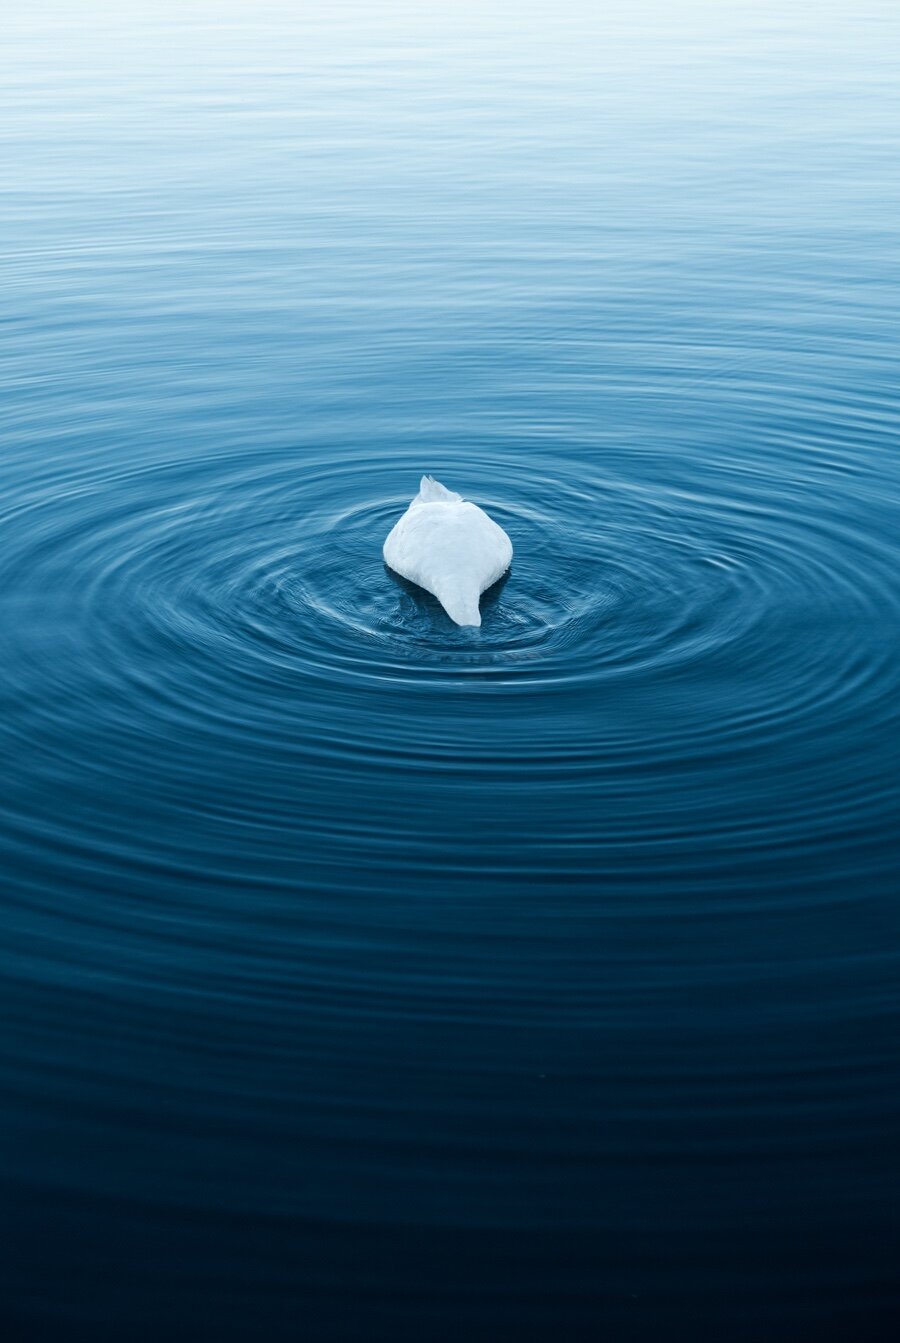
[384,475,513,624]
